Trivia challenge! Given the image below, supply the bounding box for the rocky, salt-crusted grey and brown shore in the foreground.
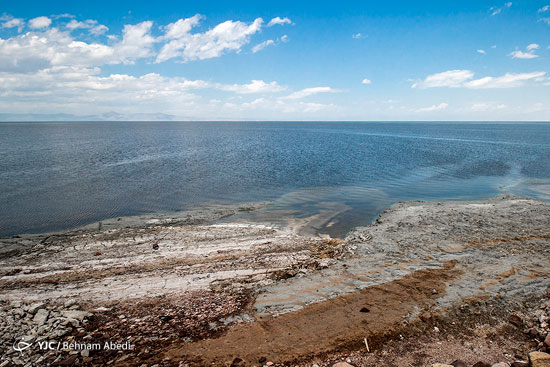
[0,195,550,366]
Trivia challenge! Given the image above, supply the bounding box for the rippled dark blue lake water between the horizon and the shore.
[0,122,550,236]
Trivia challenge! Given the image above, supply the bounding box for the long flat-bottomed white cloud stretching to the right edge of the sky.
[412,70,546,89]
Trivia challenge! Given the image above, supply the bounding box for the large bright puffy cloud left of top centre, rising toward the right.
[156,15,263,63]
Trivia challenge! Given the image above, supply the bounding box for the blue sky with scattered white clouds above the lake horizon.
[0,0,550,121]
